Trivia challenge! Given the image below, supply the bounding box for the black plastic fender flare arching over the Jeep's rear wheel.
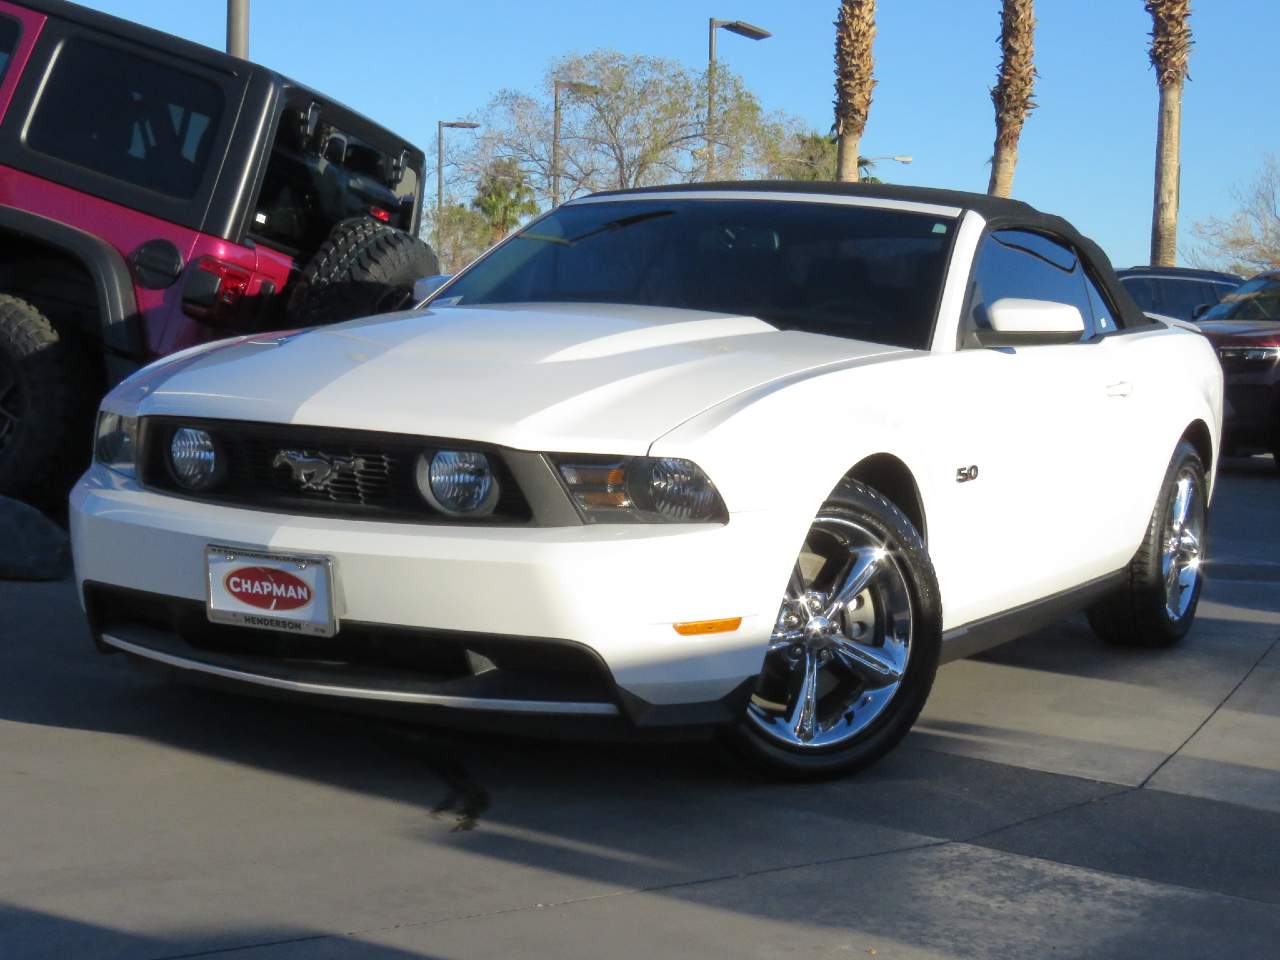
[0,206,146,383]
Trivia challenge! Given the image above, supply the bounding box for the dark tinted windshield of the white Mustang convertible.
[440,198,955,349]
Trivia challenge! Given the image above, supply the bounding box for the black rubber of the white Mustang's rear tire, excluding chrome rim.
[1088,442,1208,649]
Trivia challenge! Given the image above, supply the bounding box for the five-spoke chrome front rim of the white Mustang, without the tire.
[748,515,913,750]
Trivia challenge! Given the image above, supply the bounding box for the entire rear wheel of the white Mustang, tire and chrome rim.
[1088,442,1208,649]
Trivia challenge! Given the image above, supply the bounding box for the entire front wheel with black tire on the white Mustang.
[723,481,942,780]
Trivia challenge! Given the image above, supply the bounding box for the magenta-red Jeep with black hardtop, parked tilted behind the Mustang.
[0,0,438,503]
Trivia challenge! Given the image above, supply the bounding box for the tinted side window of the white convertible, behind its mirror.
[960,230,1095,347]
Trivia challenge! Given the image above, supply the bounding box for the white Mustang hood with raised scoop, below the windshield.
[113,305,904,454]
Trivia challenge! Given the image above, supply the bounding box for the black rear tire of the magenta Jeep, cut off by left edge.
[0,294,100,508]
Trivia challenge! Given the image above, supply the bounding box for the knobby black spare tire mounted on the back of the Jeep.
[289,216,440,326]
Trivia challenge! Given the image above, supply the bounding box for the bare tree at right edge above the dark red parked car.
[1190,154,1280,276]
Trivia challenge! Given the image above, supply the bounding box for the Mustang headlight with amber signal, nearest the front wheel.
[553,454,728,524]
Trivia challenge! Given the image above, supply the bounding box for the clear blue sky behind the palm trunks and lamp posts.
[82,0,1280,266]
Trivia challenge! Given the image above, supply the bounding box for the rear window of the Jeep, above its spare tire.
[248,111,417,257]
